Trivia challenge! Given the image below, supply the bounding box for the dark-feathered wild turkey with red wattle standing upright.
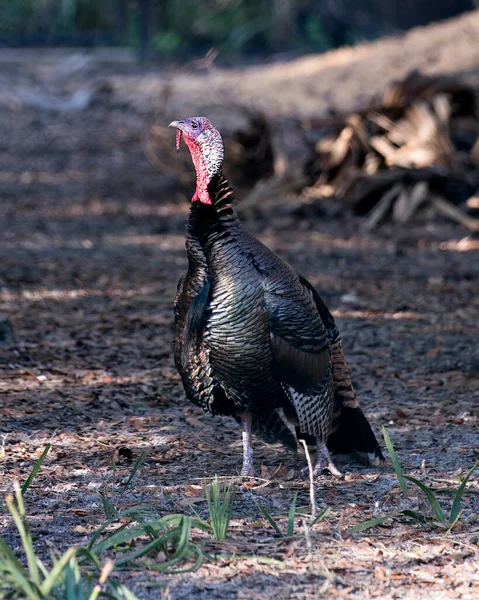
[170,117,383,475]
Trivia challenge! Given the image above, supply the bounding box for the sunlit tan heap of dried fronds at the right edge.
[302,72,479,231]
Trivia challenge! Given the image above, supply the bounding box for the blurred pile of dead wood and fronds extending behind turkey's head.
[146,71,479,231]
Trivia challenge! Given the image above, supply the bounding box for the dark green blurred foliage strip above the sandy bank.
[0,0,477,61]
